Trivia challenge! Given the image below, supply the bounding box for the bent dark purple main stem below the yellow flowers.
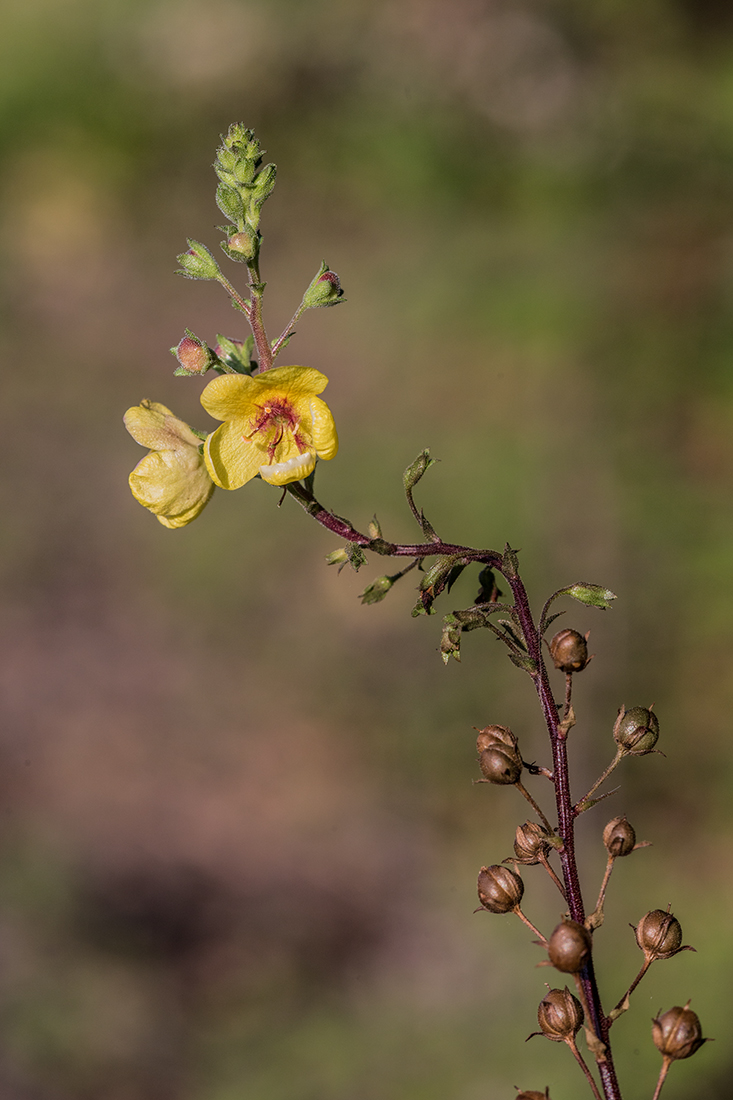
[285,482,622,1100]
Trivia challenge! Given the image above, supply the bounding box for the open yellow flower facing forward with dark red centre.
[201,366,339,488]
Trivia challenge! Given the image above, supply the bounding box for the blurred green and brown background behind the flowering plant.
[0,0,733,1100]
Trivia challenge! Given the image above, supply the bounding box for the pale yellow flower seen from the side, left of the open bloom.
[124,400,214,527]
